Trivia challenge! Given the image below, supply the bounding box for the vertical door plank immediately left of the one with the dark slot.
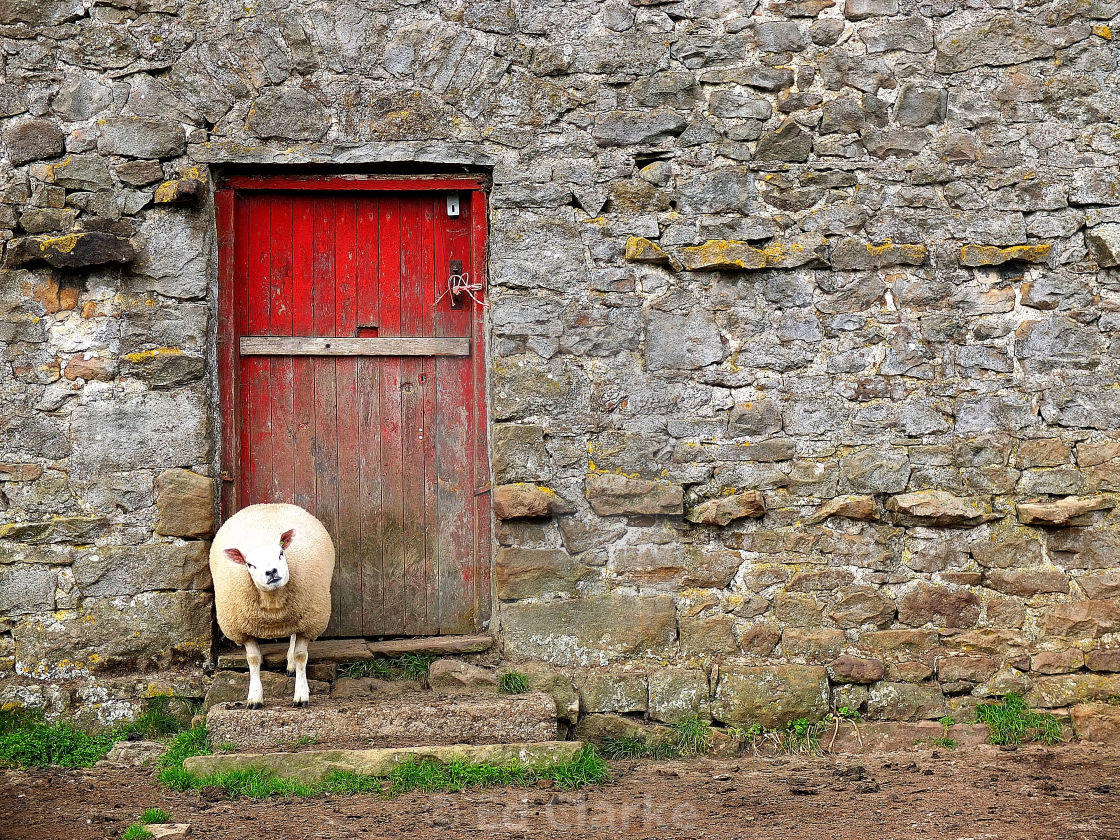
[335,194,362,635]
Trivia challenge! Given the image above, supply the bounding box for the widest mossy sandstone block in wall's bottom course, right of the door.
[711,665,829,728]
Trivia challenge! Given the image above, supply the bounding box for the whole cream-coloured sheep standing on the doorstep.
[209,504,335,709]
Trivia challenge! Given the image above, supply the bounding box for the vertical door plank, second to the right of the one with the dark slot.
[401,195,427,627]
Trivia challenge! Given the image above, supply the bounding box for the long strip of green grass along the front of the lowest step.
[157,726,608,800]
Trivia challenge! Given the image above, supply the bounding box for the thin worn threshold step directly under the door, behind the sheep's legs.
[217,633,494,671]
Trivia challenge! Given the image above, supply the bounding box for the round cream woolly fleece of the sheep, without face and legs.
[211,504,335,645]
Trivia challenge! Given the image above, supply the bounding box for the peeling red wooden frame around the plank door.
[215,175,494,628]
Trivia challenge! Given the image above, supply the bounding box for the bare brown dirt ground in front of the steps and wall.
[0,745,1120,840]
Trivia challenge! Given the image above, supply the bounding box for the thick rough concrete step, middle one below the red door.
[206,691,557,750]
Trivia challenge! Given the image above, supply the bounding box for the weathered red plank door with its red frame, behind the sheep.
[218,178,491,636]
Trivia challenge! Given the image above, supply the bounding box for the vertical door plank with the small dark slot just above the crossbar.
[356,195,385,636]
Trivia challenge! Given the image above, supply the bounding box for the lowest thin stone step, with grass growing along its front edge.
[183,740,584,784]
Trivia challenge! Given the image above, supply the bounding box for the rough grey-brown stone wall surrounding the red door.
[0,0,1120,722]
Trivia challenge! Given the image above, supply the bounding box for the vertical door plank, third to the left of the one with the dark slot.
[291,194,316,511]
